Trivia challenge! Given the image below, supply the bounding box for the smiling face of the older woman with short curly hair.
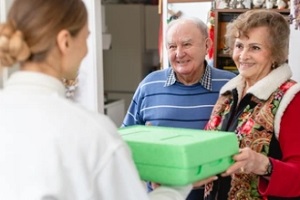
[232,27,272,84]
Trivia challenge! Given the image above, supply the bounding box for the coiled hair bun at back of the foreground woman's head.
[0,23,30,66]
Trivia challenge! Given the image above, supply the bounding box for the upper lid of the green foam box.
[119,125,239,168]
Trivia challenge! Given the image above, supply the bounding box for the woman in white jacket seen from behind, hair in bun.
[0,0,213,200]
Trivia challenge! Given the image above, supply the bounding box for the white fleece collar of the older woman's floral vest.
[220,63,292,100]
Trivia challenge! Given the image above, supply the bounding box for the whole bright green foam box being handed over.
[119,125,239,186]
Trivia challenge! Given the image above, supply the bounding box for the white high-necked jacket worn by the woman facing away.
[0,71,191,200]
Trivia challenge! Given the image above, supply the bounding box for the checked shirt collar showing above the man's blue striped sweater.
[164,61,212,91]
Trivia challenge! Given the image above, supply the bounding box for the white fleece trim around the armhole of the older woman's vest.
[274,83,300,139]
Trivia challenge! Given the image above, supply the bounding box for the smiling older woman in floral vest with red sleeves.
[206,10,300,200]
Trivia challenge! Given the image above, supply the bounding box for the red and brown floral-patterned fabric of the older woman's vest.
[205,80,295,200]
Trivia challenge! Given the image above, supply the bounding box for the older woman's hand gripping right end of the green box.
[222,147,270,176]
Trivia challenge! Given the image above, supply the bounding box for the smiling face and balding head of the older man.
[167,22,208,84]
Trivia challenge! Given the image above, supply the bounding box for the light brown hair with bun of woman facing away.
[0,0,87,66]
